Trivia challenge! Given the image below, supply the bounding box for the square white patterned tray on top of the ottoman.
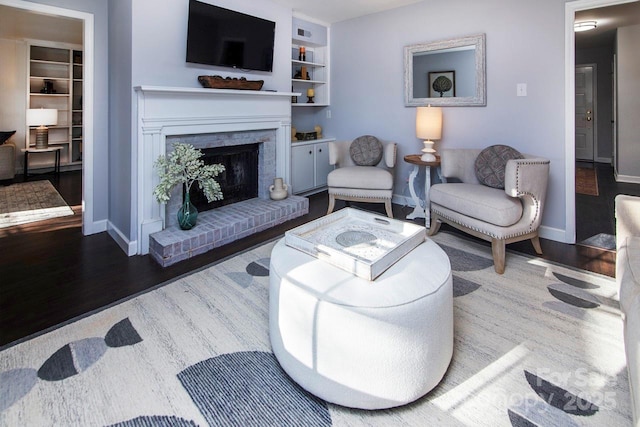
[285,208,426,280]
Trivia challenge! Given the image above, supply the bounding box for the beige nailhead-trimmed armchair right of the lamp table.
[429,146,549,274]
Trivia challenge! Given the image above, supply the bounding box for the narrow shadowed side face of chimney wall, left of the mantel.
[109,0,135,236]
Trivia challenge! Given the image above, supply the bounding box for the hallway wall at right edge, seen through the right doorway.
[616,25,640,183]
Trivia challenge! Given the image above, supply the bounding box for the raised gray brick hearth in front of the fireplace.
[149,196,309,267]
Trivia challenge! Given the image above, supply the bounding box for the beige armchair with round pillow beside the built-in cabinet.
[327,135,397,218]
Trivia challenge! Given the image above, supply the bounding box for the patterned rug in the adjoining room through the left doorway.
[0,181,73,228]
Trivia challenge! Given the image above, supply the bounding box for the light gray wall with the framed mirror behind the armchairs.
[327,0,566,231]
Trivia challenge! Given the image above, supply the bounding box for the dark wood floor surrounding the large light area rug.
[0,164,640,346]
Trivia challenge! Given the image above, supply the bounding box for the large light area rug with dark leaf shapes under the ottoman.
[0,232,631,427]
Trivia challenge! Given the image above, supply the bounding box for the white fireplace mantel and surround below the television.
[135,86,294,255]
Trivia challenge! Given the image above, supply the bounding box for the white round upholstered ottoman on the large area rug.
[269,239,453,409]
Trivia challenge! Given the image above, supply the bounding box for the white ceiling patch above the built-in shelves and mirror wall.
[273,0,424,24]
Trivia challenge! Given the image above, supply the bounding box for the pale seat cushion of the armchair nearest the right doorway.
[429,183,522,227]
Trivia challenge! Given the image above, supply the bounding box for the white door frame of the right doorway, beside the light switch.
[564,0,637,244]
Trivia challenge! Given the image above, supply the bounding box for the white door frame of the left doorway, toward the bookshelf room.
[0,0,95,236]
